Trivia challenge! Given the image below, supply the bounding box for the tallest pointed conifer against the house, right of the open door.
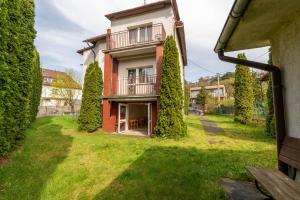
[155,36,187,138]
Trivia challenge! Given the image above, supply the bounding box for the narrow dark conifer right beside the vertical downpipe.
[266,48,275,136]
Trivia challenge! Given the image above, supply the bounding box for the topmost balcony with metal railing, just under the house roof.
[108,24,166,50]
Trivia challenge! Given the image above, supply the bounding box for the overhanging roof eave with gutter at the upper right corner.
[214,0,300,52]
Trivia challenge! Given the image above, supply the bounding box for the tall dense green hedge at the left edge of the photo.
[0,0,37,157]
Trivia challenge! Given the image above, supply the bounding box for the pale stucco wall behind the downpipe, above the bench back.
[272,15,300,138]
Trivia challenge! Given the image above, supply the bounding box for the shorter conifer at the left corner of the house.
[78,62,103,132]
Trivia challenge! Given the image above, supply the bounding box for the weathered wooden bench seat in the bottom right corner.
[246,166,300,200]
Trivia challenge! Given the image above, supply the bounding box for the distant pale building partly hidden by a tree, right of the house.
[190,85,227,104]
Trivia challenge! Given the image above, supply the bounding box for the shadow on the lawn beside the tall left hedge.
[0,118,72,200]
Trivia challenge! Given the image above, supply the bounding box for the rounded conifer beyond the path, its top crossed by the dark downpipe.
[234,54,254,124]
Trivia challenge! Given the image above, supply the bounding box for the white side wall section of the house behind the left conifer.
[82,41,106,86]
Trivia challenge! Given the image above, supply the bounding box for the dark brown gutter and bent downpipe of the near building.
[214,0,288,174]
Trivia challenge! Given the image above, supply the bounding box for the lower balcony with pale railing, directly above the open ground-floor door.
[118,75,157,96]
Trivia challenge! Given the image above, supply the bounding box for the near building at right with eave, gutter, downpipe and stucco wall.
[215,0,300,181]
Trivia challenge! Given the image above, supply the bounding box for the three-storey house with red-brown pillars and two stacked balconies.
[78,0,187,135]
